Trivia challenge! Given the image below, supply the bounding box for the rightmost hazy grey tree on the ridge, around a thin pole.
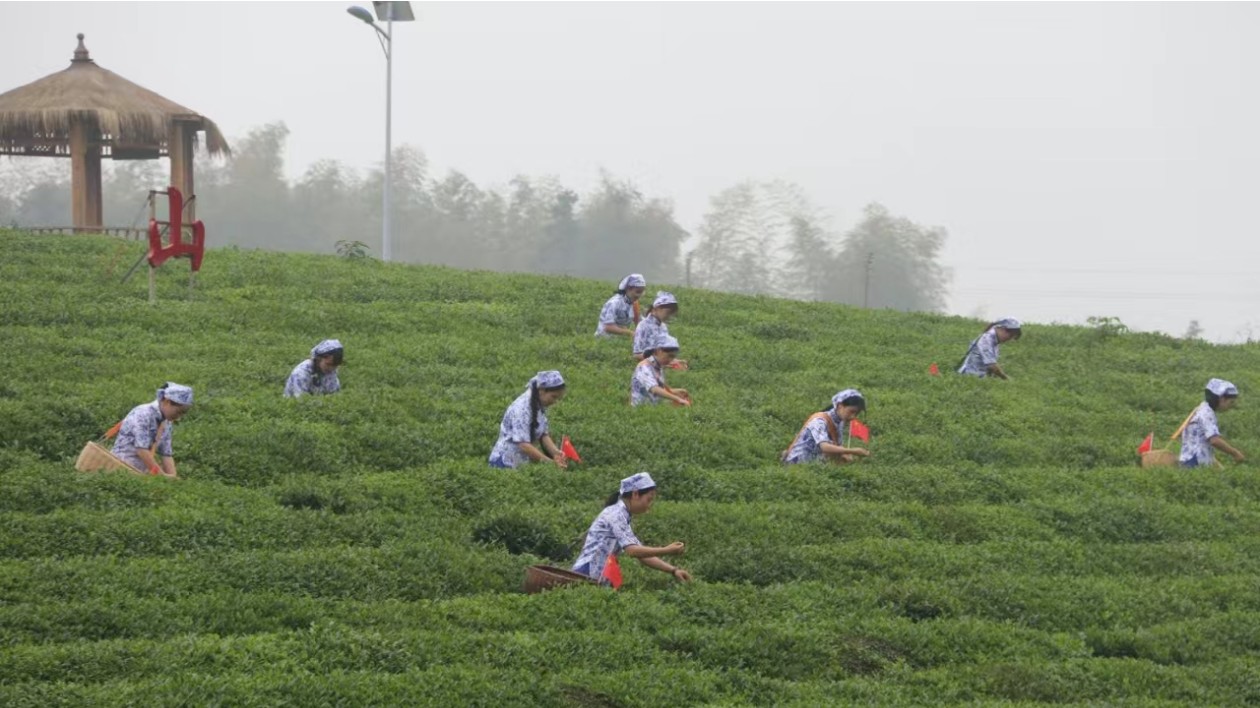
[828,204,949,312]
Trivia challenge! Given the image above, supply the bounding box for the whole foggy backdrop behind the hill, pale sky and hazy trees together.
[0,1,1260,341]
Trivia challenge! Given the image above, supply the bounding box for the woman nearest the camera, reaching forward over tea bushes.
[572,472,692,587]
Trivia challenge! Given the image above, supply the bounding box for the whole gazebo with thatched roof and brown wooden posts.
[0,34,229,231]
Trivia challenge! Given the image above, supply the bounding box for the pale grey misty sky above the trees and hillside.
[0,0,1260,341]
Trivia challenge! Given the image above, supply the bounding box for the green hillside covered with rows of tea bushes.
[0,232,1260,707]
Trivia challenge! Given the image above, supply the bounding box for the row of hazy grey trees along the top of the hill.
[0,122,950,311]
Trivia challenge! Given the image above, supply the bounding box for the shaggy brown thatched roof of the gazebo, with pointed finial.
[0,34,229,155]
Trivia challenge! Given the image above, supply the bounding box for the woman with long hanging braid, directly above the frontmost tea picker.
[490,370,568,469]
